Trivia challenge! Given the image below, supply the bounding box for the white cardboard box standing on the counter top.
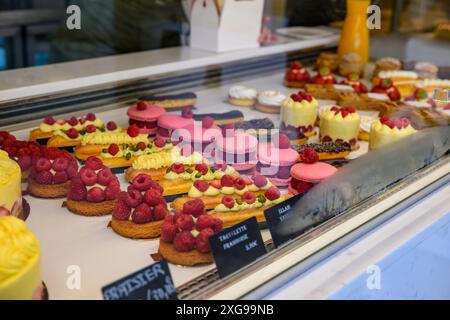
[190,0,264,52]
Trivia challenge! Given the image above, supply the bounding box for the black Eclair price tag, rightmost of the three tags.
[264,194,303,247]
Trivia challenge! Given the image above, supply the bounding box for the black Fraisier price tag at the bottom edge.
[102,260,178,300]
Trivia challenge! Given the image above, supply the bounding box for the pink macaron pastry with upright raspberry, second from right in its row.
[256,134,298,187]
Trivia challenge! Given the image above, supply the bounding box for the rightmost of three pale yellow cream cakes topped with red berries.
[369,116,417,150]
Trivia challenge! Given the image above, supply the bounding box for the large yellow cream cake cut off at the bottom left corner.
[0,216,42,300]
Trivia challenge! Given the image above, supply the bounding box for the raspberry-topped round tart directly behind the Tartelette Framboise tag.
[158,199,223,266]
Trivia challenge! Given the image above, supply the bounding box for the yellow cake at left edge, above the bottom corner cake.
[0,150,22,217]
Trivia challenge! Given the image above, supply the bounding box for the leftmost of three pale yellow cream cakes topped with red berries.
[280,91,319,137]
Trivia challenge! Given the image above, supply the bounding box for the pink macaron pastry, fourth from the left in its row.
[216,130,258,174]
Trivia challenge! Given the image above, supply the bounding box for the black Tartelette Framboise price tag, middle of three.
[209,217,267,278]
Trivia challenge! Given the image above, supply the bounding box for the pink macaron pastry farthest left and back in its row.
[127,101,166,136]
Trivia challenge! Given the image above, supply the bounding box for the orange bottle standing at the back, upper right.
[338,0,370,63]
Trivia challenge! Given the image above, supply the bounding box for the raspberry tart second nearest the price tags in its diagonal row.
[110,175,169,239]
